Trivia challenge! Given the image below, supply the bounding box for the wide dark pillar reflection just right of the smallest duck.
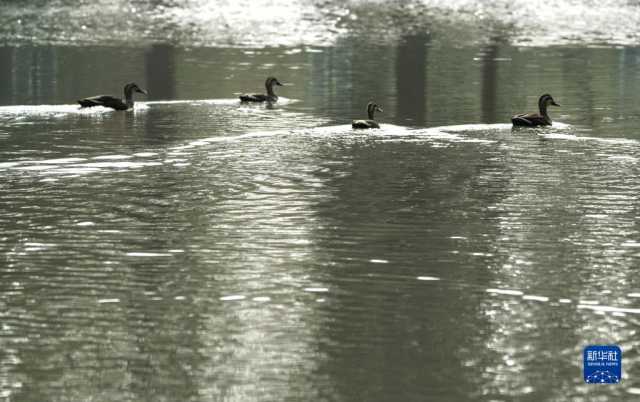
[396,34,429,125]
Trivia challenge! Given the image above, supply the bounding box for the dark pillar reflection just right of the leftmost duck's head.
[145,45,176,99]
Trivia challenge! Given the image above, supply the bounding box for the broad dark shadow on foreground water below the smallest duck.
[306,137,510,401]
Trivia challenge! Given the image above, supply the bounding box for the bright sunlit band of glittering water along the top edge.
[0,0,640,47]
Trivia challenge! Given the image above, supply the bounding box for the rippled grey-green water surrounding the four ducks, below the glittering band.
[0,0,640,402]
